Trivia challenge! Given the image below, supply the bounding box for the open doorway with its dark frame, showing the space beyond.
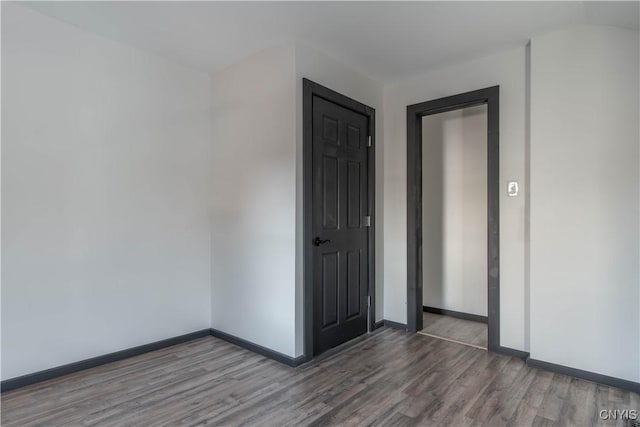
[407,86,500,351]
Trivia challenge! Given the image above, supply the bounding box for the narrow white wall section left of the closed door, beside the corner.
[210,45,296,356]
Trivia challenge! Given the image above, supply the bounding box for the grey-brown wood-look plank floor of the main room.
[2,328,640,427]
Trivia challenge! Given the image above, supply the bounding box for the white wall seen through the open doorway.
[422,105,487,316]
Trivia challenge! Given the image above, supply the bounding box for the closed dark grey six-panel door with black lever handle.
[313,96,369,354]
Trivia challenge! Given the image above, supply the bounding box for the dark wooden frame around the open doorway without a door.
[407,86,500,351]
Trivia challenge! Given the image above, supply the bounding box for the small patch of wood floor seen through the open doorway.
[422,313,487,348]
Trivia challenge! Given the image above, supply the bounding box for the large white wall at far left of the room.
[2,2,210,379]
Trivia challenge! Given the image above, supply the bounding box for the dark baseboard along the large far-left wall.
[0,329,210,392]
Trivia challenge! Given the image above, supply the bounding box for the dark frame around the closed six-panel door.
[302,78,376,361]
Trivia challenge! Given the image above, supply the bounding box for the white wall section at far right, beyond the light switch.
[530,27,640,381]
